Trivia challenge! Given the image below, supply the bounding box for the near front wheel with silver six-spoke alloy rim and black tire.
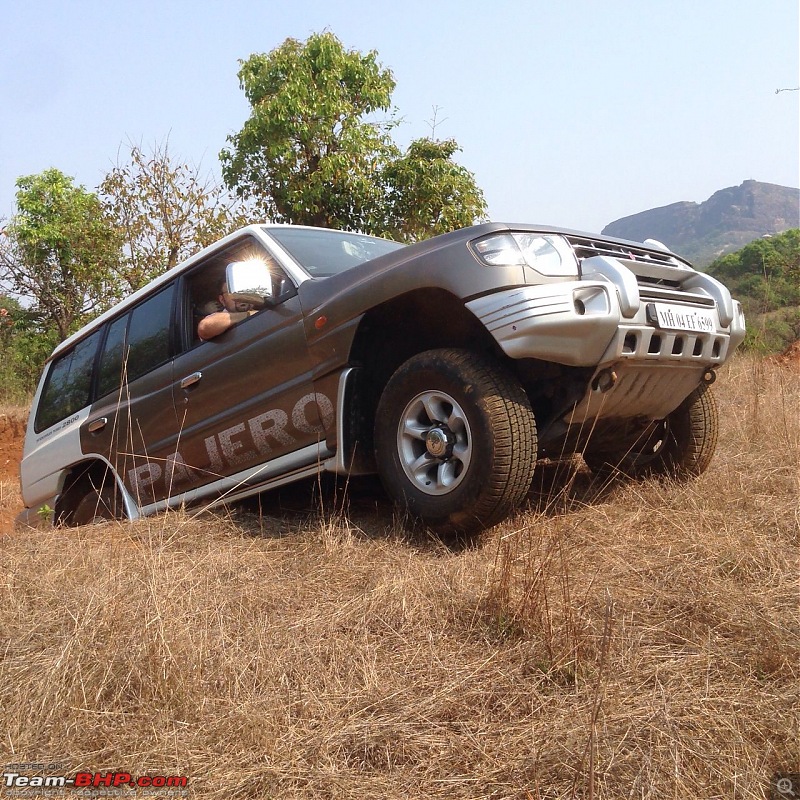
[375,349,537,534]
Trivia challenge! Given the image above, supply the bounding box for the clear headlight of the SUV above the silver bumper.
[470,233,578,278]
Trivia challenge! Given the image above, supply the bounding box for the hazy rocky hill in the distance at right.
[603,180,800,267]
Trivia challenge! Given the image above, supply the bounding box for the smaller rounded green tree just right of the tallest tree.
[385,139,486,242]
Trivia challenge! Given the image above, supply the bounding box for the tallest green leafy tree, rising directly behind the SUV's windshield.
[220,33,396,230]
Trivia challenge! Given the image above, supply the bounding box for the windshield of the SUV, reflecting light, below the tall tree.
[264,226,405,278]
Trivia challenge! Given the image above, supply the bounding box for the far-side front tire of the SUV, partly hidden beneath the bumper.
[584,383,719,480]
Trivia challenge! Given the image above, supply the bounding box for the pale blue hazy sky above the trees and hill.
[0,0,800,232]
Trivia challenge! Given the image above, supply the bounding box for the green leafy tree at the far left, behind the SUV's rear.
[0,169,121,340]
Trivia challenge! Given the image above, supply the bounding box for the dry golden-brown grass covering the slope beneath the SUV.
[0,359,800,800]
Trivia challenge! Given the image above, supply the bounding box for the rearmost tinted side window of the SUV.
[33,331,100,433]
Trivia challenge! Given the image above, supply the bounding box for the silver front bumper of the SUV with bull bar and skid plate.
[467,257,745,426]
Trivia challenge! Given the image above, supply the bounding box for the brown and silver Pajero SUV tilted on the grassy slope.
[21,223,745,533]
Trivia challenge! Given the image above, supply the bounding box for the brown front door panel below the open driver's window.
[172,293,323,490]
